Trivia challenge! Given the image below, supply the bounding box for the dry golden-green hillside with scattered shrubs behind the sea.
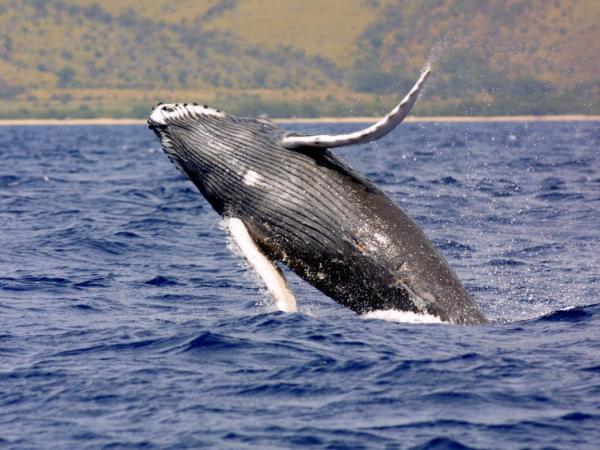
[0,0,600,117]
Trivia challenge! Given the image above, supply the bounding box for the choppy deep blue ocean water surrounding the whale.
[0,122,600,449]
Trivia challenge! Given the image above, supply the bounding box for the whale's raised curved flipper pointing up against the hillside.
[281,66,431,149]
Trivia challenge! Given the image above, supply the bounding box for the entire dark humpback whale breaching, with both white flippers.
[148,67,486,325]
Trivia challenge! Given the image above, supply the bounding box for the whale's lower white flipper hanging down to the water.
[225,218,298,312]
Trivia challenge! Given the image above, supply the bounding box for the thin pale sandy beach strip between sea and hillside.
[0,114,600,126]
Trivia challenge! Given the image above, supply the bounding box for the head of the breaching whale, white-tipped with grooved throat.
[148,103,285,213]
